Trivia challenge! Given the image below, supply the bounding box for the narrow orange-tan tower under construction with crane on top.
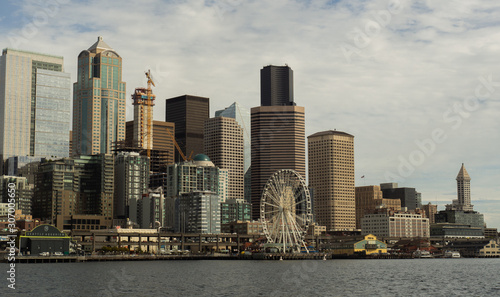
[132,70,156,157]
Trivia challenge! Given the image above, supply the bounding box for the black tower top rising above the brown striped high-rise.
[260,65,295,106]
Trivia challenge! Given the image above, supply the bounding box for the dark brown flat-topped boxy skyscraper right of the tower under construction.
[165,95,210,162]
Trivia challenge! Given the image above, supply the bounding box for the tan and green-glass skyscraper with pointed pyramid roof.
[73,36,125,155]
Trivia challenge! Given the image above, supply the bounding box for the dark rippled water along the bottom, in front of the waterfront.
[0,259,500,297]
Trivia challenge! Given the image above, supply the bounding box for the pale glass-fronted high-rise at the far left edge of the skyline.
[0,48,71,161]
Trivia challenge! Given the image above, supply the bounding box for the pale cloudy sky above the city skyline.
[0,0,500,228]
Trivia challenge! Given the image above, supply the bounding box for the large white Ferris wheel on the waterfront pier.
[260,169,312,252]
